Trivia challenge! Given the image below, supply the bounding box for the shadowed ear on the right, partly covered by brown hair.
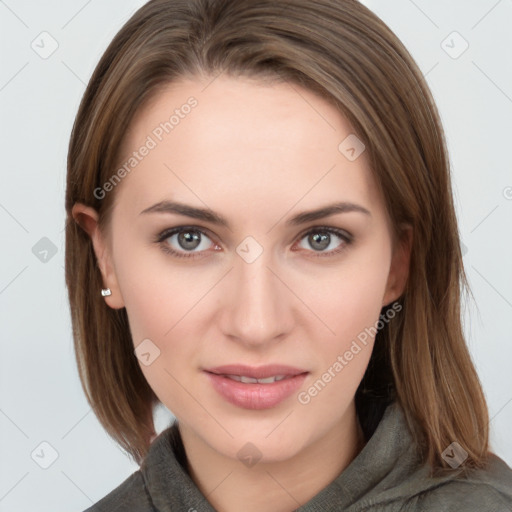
[382,224,413,306]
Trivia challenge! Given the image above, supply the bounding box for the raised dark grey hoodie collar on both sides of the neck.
[141,401,439,512]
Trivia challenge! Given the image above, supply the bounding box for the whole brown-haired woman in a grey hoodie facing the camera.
[66,0,512,512]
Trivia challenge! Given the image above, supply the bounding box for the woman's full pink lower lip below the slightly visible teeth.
[205,372,307,409]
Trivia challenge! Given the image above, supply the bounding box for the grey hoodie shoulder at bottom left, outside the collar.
[84,470,155,512]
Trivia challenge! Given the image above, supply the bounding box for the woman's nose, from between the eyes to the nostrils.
[219,251,298,348]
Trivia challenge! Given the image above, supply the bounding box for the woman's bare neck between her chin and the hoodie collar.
[180,403,365,512]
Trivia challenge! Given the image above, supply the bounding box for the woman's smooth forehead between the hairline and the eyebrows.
[111,76,379,224]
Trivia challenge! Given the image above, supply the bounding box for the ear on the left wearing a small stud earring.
[71,203,124,309]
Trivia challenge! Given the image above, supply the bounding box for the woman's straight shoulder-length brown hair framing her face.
[65,0,489,474]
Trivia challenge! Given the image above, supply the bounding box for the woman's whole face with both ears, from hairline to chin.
[75,76,406,461]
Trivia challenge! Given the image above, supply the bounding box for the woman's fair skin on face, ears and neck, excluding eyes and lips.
[73,76,411,512]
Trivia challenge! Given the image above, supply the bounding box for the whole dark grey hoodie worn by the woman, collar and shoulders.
[85,402,512,512]
